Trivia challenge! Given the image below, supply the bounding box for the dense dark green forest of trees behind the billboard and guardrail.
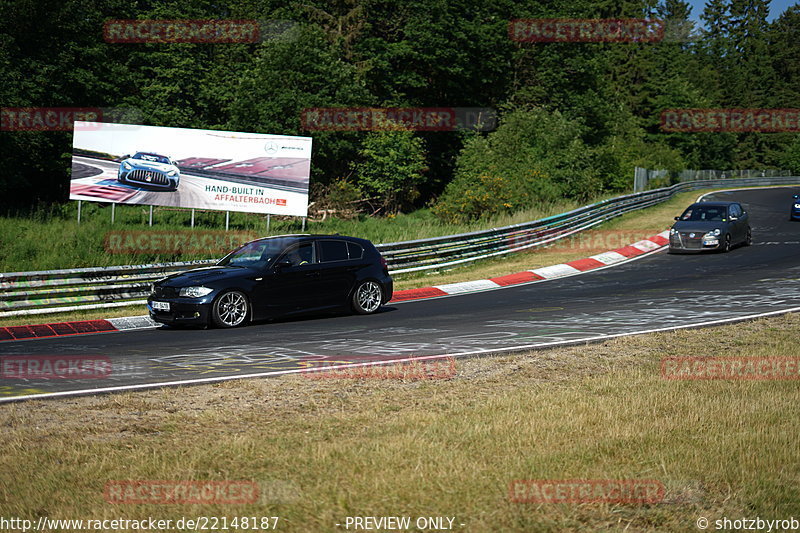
[0,0,800,221]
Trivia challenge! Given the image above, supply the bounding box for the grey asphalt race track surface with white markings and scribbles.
[0,188,800,400]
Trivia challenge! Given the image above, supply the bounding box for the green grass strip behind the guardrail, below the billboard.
[0,194,596,272]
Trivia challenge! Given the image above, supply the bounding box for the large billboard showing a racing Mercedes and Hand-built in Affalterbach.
[69,121,311,217]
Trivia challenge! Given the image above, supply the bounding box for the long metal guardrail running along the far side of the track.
[0,177,800,316]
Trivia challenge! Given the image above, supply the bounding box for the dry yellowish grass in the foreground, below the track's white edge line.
[0,315,800,531]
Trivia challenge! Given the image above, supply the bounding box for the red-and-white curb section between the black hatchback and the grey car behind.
[390,231,669,303]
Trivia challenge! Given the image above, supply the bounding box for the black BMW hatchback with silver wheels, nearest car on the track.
[147,235,393,328]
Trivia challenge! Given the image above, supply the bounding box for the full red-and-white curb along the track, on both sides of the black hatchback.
[0,231,669,341]
